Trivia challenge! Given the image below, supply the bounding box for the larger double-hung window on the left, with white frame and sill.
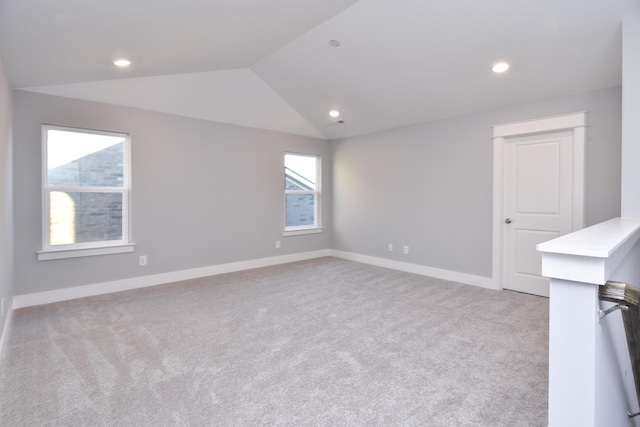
[38,125,133,260]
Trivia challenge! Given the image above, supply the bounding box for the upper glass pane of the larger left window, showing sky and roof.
[47,129,125,187]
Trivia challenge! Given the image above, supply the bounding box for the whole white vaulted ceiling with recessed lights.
[0,0,640,139]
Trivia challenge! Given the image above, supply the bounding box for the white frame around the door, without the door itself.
[491,111,587,289]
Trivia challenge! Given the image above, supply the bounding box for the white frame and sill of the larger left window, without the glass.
[37,124,134,261]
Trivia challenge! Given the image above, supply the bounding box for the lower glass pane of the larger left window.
[49,191,123,245]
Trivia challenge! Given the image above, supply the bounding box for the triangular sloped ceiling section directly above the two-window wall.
[27,68,326,138]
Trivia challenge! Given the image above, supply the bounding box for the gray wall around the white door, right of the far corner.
[332,87,621,277]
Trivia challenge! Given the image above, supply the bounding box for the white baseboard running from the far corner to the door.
[330,249,500,290]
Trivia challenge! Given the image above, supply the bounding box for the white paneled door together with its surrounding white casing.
[492,112,586,295]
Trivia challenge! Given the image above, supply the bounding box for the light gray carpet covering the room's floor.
[0,258,548,426]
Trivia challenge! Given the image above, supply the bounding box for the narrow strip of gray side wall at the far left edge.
[0,52,13,334]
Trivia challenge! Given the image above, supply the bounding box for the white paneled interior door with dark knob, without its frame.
[503,131,573,296]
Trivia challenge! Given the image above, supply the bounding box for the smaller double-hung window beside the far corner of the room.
[284,153,322,235]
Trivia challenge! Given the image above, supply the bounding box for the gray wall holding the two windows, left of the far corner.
[13,90,331,295]
